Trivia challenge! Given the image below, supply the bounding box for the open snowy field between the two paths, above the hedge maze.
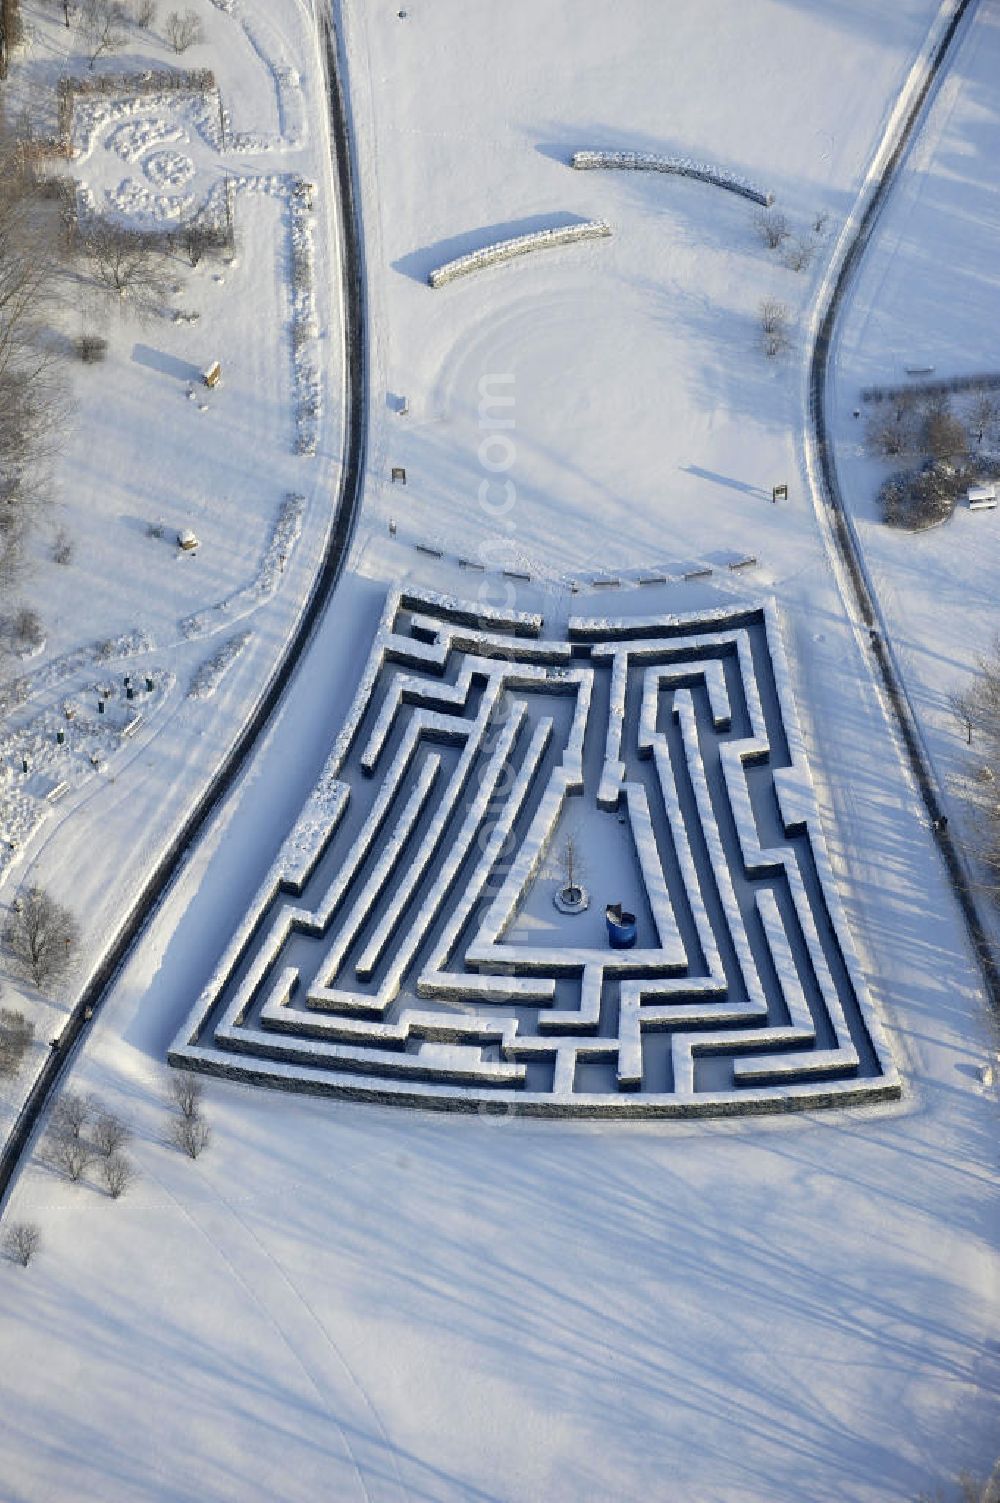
[346,0,937,580]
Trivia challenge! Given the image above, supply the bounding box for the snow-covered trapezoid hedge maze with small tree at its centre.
[170,591,899,1115]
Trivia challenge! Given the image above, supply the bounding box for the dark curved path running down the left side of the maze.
[0,0,368,1208]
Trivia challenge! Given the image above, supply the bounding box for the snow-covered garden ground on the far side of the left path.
[0,0,343,1121]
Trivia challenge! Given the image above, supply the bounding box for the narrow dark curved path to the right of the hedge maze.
[809,0,1000,1012]
